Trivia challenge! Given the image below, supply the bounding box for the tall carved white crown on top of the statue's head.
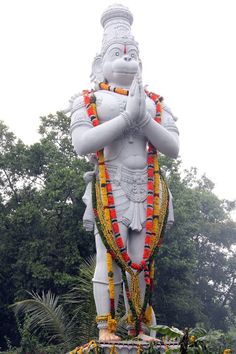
[101,4,138,53]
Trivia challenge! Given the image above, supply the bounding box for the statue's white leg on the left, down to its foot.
[93,225,127,340]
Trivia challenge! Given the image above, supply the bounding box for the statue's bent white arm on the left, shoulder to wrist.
[71,97,128,155]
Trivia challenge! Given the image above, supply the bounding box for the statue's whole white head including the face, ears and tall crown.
[91,5,141,87]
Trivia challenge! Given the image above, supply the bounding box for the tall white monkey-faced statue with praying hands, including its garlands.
[70,5,179,341]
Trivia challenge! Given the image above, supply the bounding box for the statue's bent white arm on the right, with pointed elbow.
[143,105,179,158]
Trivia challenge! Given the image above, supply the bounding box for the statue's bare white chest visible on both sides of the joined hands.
[95,91,155,123]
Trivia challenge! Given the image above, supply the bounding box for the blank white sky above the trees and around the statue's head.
[0,0,236,213]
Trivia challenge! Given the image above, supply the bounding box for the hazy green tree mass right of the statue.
[155,159,236,330]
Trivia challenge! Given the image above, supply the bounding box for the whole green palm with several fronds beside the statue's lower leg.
[12,257,97,352]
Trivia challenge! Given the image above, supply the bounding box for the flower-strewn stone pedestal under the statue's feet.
[74,340,179,354]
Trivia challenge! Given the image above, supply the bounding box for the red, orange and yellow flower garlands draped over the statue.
[83,83,168,334]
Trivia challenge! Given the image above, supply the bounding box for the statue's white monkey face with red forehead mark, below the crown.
[102,44,140,87]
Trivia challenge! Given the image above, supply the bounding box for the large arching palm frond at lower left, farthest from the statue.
[12,291,73,344]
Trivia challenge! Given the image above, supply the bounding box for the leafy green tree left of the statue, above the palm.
[0,117,94,346]
